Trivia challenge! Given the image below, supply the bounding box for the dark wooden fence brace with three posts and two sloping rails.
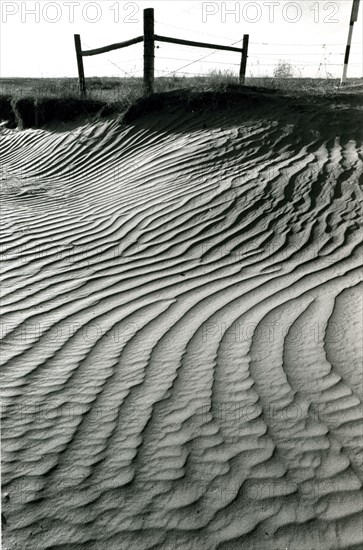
[74,8,249,97]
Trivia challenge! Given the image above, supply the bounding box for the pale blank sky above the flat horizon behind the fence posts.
[0,0,363,78]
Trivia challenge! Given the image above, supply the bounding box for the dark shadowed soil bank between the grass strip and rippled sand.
[0,85,362,136]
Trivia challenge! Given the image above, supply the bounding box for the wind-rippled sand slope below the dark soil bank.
[0,95,363,550]
